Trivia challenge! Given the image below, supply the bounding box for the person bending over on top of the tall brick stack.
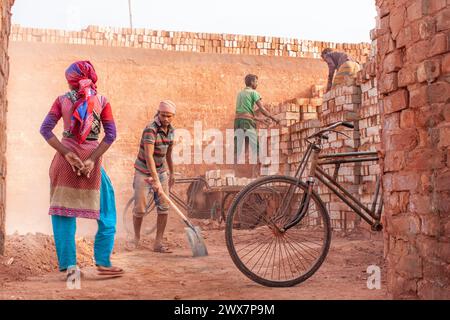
[321,48,361,91]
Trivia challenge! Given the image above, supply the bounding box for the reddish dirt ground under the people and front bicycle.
[0,218,389,300]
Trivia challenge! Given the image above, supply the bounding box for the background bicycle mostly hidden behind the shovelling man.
[122,173,209,237]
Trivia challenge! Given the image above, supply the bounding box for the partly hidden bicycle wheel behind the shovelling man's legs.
[123,197,156,237]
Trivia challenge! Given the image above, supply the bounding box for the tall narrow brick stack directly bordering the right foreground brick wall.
[357,59,381,212]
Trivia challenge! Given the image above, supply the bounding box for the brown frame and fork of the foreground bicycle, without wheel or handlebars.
[282,136,383,231]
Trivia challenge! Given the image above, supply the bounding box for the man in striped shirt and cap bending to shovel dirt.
[129,100,176,253]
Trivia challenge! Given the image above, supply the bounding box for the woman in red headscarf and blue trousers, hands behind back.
[40,61,123,277]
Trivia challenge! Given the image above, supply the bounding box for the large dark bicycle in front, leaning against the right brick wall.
[225,122,383,287]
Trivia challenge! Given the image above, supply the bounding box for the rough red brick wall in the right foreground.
[372,0,450,299]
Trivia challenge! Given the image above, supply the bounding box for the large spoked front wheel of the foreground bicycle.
[225,176,331,287]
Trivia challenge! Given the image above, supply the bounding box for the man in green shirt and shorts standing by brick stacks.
[234,74,280,177]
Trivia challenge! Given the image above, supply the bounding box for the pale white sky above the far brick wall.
[12,0,376,42]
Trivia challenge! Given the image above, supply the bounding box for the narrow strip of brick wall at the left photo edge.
[0,0,14,255]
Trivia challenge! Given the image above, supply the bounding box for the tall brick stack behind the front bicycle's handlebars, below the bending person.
[318,84,361,231]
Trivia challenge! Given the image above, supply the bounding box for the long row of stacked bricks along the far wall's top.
[11,25,370,62]
